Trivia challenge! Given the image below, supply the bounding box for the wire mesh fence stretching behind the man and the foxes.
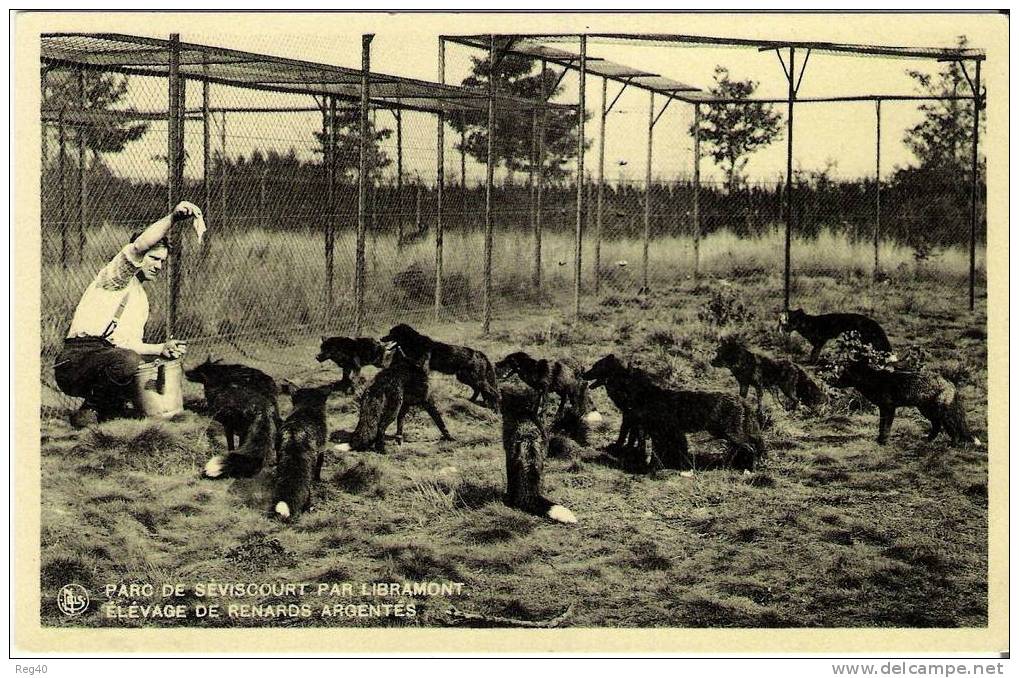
[41,33,985,407]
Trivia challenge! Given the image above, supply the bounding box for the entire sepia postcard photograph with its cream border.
[12,12,1009,653]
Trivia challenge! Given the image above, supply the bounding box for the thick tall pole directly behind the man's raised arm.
[166,33,184,338]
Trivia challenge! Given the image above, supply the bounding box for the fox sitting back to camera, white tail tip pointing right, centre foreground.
[502,386,577,523]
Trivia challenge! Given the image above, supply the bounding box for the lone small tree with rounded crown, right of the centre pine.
[690,66,782,192]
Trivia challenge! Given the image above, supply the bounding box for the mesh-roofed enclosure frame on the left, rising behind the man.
[41,33,573,336]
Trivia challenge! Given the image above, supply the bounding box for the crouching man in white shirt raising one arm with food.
[53,202,202,428]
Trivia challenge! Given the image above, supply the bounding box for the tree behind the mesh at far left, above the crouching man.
[42,69,149,154]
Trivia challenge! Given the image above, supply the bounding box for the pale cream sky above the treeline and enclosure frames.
[41,14,998,188]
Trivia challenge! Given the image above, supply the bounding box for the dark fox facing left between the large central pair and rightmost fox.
[711,338,824,418]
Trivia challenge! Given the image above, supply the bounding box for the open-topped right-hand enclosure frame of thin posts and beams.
[439,33,986,315]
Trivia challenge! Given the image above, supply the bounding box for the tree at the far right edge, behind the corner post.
[903,36,982,172]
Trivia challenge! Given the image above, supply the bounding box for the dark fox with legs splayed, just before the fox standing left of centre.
[348,348,453,452]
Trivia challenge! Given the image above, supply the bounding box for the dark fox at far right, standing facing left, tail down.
[835,360,980,445]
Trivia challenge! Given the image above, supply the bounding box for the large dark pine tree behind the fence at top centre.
[448,54,590,178]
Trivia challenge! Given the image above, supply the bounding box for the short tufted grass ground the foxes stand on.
[41,273,987,627]
